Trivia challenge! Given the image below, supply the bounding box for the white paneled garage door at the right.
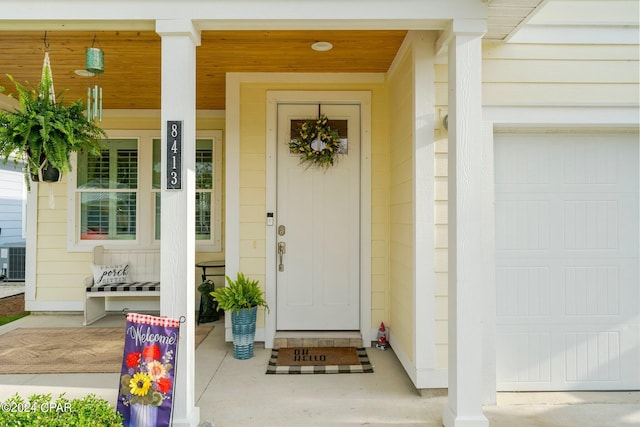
[495,134,640,391]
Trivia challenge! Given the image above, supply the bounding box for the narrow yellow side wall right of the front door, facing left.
[389,49,415,361]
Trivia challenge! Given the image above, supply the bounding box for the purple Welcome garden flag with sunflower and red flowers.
[117,313,180,427]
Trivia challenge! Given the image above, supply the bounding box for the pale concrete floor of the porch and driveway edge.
[0,314,640,427]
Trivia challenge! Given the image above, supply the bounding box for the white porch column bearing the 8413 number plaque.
[156,20,200,427]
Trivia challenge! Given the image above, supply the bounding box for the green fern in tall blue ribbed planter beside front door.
[211,273,269,359]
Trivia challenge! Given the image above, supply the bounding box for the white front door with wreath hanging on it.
[273,104,360,330]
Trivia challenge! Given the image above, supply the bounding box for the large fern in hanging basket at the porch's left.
[0,60,107,184]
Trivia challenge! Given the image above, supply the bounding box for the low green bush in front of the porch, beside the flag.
[0,393,122,427]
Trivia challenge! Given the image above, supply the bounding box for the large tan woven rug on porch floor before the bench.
[0,325,213,374]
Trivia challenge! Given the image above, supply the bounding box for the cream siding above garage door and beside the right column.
[435,38,640,369]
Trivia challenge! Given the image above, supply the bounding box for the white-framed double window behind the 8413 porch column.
[68,131,222,252]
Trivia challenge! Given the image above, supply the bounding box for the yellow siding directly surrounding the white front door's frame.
[239,83,390,327]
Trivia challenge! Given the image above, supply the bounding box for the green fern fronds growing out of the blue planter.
[211,273,269,313]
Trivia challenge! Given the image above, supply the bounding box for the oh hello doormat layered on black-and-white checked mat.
[266,347,373,374]
